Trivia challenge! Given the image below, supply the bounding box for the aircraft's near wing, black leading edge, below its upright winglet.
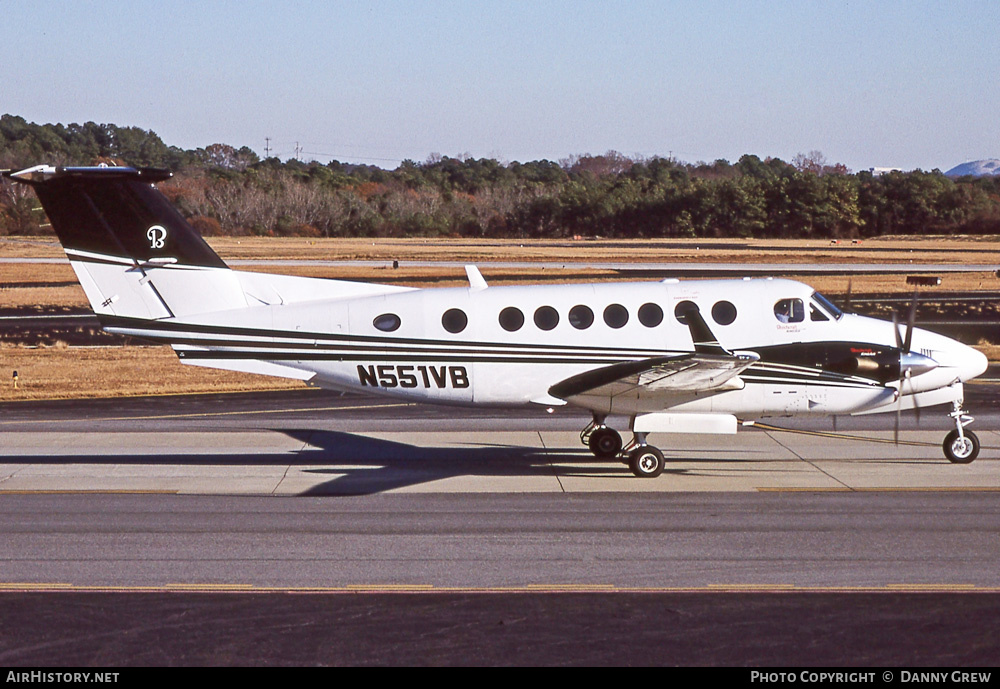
[549,352,757,399]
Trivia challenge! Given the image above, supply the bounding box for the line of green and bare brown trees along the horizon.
[0,115,1000,238]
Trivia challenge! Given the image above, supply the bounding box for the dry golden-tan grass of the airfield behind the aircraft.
[0,237,1000,401]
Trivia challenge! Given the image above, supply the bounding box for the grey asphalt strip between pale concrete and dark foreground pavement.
[0,492,1000,593]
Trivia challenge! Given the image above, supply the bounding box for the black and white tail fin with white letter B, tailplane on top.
[4,165,247,319]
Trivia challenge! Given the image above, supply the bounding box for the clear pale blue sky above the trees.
[0,0,1000,170]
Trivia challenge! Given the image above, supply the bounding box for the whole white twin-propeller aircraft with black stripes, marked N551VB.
[5,165,987,477]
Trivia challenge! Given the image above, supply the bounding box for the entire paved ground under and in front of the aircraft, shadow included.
[0,383,1000,666]
